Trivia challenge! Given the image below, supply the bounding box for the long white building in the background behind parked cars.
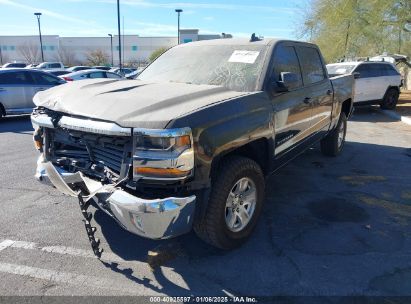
[0,29,221,65]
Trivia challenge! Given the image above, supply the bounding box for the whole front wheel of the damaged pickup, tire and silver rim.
[194,156,265,250]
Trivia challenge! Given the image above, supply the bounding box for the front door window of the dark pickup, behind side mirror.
[273,45,303,89]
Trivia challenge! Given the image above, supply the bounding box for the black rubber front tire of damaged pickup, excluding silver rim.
[194,156,265,250]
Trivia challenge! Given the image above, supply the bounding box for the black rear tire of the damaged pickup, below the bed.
[321,112,347,156]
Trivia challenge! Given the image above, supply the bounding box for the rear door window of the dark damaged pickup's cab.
[297,46,325,85]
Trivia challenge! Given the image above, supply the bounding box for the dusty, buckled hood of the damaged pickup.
[33,79,250,129]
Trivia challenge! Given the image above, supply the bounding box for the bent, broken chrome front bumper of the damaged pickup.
[35,156,196,239]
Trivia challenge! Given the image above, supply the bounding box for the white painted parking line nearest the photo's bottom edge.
[0,262,151,294]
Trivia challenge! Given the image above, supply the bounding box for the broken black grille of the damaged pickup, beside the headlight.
[50,129,131,175]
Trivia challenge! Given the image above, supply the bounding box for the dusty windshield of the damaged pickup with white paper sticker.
[137,45,267,92]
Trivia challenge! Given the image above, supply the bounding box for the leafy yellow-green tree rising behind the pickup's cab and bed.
[299,0,411,62]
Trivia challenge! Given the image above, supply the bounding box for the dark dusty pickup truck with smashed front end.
[31,37,353,249]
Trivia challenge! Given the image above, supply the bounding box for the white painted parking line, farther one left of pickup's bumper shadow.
[0,240,140,264]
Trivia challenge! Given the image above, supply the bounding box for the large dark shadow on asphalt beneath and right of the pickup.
[95,142,411,296]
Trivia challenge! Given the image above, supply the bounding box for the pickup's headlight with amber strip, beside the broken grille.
[133,128,194,180]
